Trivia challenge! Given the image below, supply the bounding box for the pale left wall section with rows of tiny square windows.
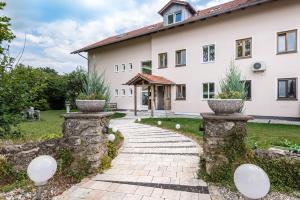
[88,37,151,109]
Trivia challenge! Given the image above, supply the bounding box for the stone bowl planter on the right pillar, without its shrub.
[207,99,244,115]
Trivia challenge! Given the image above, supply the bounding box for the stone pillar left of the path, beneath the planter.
[63,113,112,169]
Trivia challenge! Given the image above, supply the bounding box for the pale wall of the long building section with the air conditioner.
[152,0,300,117]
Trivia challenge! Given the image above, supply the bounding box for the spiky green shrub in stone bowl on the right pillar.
[208,61,247,115]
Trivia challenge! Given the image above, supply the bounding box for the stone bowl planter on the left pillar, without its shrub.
[75,100,105,113]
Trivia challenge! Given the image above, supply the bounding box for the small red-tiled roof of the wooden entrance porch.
[125,73,175,85]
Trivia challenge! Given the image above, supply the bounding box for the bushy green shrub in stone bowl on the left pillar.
[75,71,110,113]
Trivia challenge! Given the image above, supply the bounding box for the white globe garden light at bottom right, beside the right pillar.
[234,164,270,199]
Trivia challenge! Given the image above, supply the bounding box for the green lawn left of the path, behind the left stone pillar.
[0,110,126,143]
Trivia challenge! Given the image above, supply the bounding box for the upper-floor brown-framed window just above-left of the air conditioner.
[236,38,252,59]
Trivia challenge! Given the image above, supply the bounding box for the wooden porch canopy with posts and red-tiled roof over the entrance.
[124,73,175,116]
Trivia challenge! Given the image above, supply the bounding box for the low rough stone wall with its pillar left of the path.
[0,113,111,170]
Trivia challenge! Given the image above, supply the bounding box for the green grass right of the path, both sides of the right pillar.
[141,118,300,149]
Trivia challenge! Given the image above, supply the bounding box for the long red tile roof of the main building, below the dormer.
[72,0,274,54]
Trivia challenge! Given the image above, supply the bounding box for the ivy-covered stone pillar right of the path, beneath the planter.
[201,113,252,174]
